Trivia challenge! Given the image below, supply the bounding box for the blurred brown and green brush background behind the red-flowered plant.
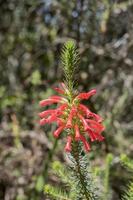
[0,0,133,200]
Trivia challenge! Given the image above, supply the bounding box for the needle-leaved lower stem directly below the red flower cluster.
[69,142,99,200]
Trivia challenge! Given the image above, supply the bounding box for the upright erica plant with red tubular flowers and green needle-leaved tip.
[39,41,104,200]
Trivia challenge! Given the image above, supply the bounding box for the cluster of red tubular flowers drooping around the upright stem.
[39,83,104,152]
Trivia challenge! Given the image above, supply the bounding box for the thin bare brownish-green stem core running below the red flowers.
[72,142,92,200]
